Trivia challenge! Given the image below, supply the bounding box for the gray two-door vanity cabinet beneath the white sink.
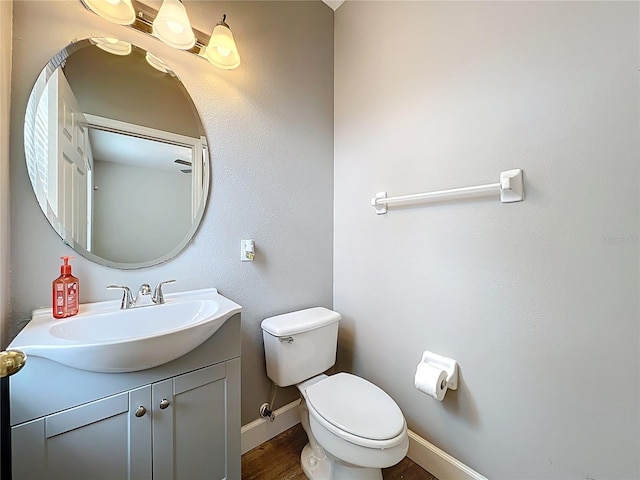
[11,315,240,480]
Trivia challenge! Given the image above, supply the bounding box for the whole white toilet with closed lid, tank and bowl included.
[262,307,409,480]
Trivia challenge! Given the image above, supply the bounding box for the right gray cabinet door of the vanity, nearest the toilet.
[152,359,240,480]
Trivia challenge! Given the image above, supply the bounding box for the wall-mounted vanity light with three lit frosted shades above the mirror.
[80,0,240,70]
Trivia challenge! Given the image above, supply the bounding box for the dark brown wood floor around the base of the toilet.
[242,424,438,480]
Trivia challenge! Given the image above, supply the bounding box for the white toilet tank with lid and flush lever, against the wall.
[262,307,342,387]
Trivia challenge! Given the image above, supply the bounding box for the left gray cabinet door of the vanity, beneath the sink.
[12,386,152,480]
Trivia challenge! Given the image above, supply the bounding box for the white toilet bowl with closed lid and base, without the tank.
[297,373,409,480]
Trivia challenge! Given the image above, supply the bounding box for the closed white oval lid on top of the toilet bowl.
[305,373,404,440]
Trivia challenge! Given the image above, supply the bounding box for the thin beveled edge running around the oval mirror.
[23,38,212,270]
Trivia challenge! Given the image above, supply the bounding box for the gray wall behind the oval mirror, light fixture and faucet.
[10,0,333,424]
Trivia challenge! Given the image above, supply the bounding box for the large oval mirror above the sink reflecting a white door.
[24,38,209,269]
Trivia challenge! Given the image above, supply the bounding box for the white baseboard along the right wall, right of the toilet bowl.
[407,430,488,480]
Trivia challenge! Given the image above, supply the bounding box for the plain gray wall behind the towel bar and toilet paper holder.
[334,1,640,479]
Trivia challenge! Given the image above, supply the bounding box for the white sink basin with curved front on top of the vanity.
[9,288,242,373]
